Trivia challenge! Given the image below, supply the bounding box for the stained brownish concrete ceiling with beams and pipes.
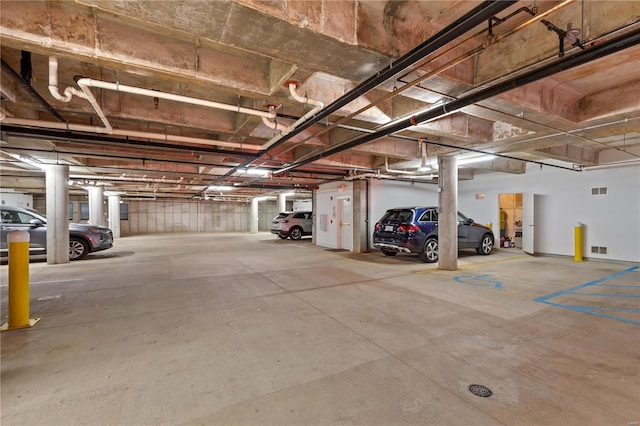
[0,0,640,200]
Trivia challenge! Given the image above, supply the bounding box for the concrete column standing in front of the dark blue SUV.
[438,156,458,271]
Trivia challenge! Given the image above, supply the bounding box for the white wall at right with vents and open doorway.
[458,163,640,262]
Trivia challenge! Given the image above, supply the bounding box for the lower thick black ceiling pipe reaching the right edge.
[274,30,640,174]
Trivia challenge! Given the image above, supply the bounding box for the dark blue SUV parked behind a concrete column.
[373,207,494,263]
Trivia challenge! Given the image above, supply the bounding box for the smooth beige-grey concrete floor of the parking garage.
[0,233,640,426]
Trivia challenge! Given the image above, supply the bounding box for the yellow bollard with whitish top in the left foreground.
[0,231,40,331]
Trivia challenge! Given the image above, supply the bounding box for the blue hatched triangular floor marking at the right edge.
[534,266,640,325]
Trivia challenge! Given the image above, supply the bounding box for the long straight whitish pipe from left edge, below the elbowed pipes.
[0,117,261,151]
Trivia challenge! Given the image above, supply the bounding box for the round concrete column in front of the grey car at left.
[44,164,69,264]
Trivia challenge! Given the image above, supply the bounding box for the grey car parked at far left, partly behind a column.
[0,206,113,260]
